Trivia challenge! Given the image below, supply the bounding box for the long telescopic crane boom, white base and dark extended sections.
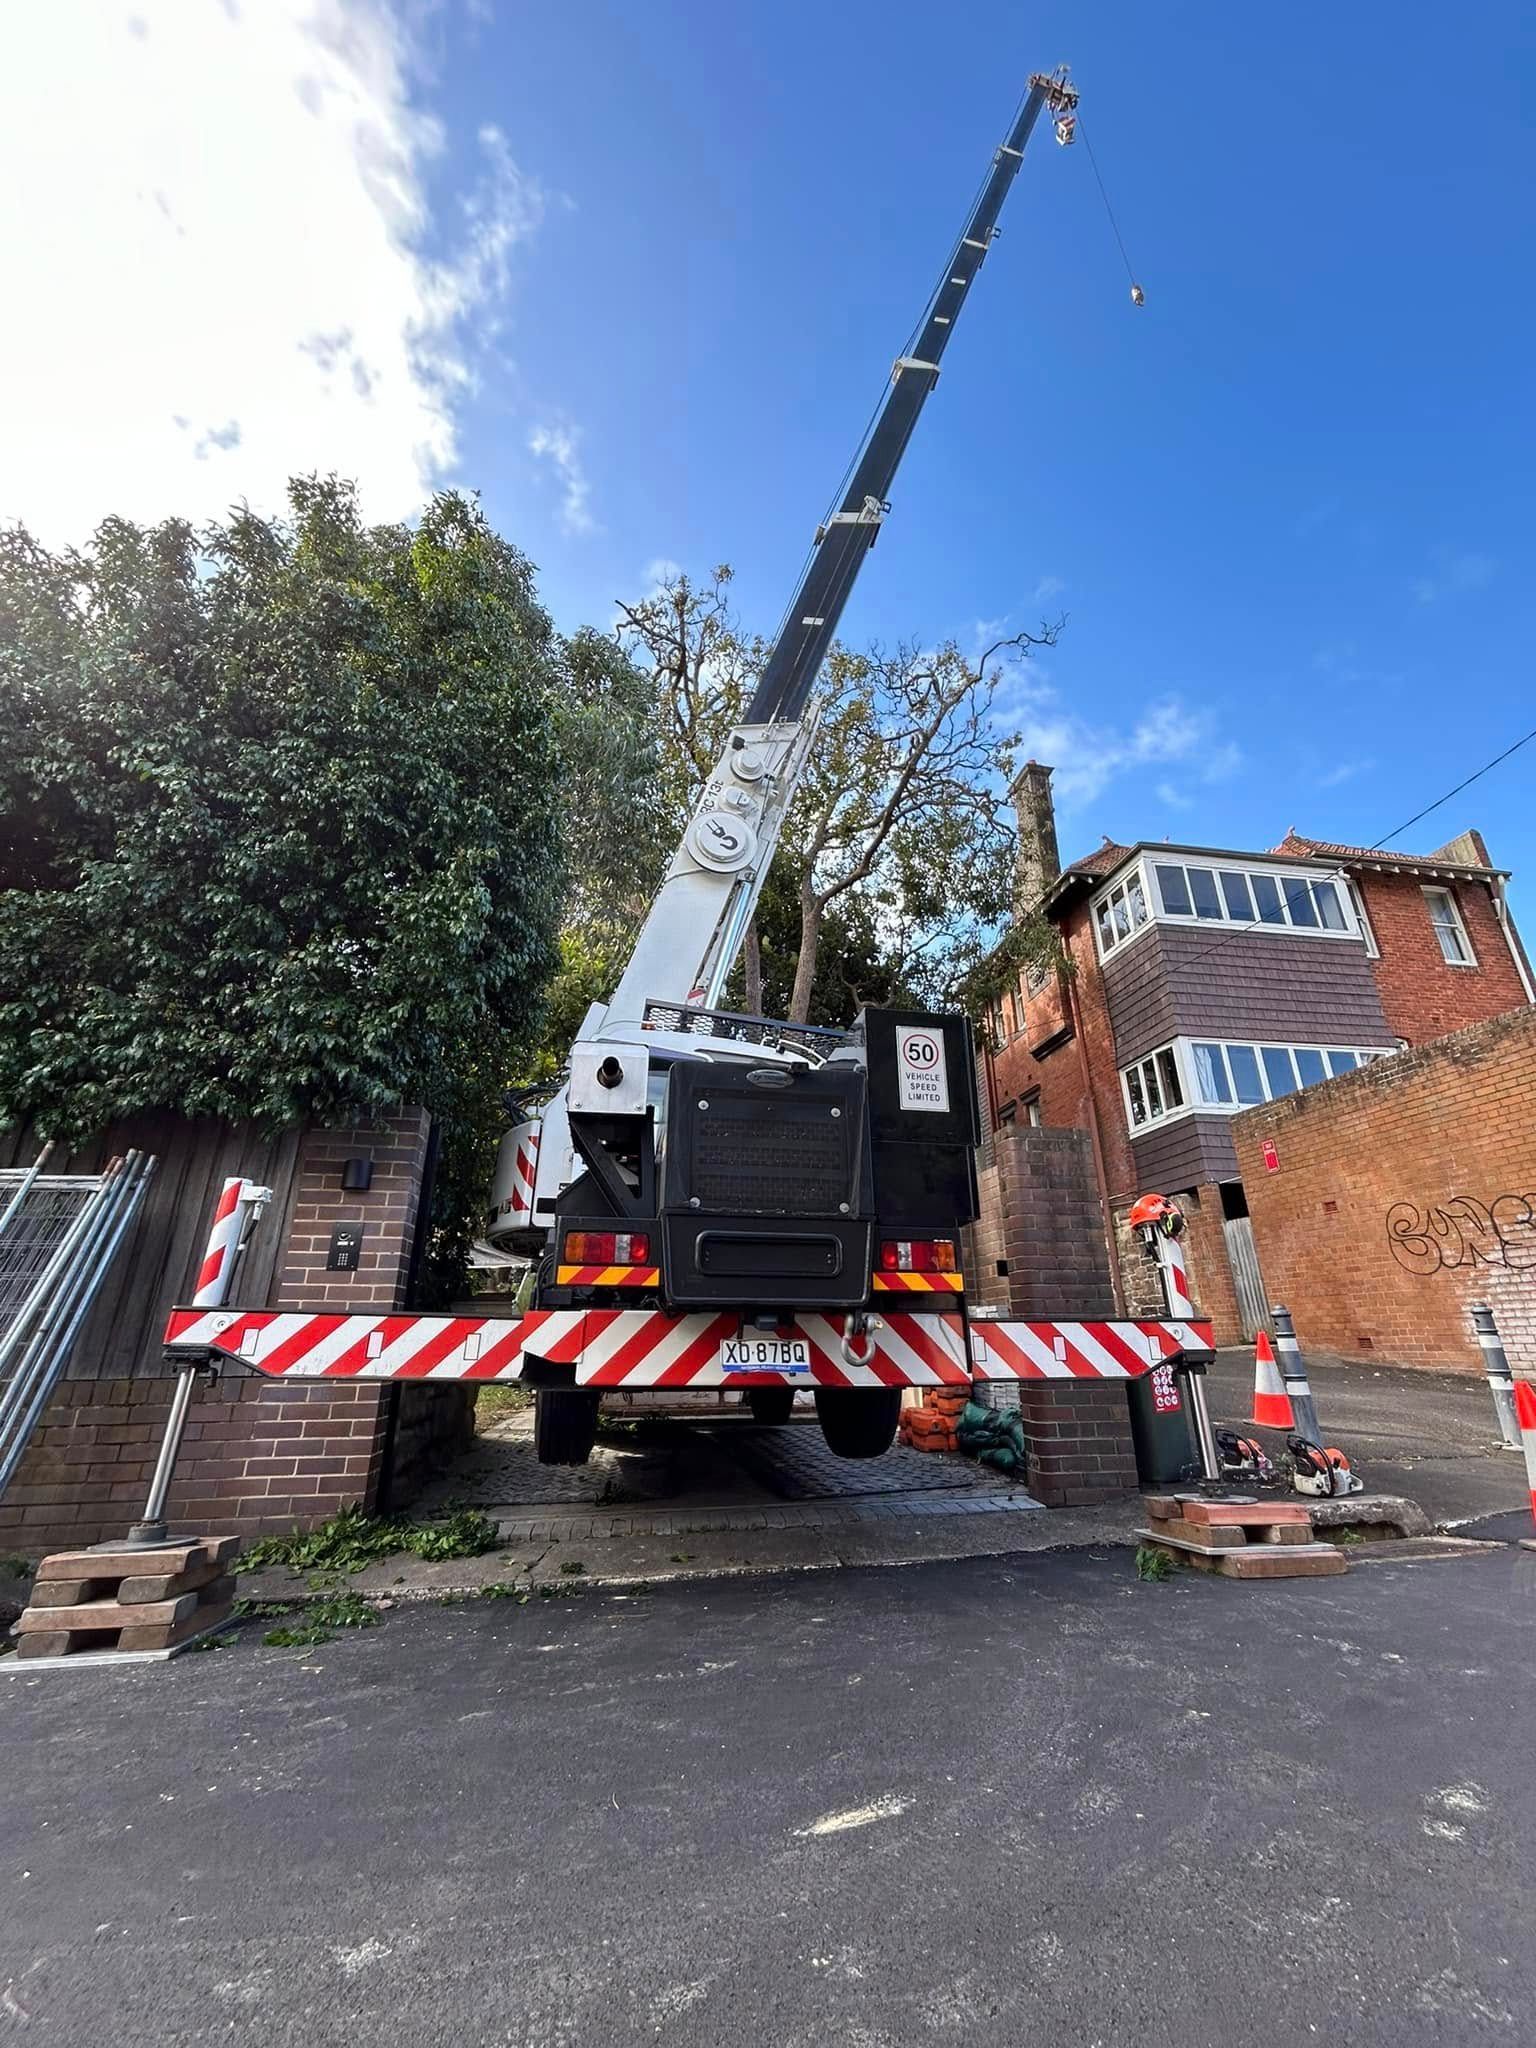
[606,66,1077,1024]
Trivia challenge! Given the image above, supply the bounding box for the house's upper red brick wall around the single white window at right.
[1356,872,1526,1044]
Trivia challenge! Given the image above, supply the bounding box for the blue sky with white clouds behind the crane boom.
[0,0,1536,926]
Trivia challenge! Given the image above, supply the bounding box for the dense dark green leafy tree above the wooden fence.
[0,479,577,1171]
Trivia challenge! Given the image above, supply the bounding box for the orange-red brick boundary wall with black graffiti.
[1233,1008,1536,1372]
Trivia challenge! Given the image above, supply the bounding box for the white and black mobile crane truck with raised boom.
[166,66,1208,1464]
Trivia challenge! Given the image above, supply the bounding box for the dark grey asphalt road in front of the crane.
[0,1550,1536,2048]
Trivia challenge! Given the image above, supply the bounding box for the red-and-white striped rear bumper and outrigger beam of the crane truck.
[166,1309,1210,1389]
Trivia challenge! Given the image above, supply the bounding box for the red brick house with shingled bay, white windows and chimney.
[983,762,1532,1341]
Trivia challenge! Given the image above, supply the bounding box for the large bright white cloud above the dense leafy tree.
[0,0,545,541]
